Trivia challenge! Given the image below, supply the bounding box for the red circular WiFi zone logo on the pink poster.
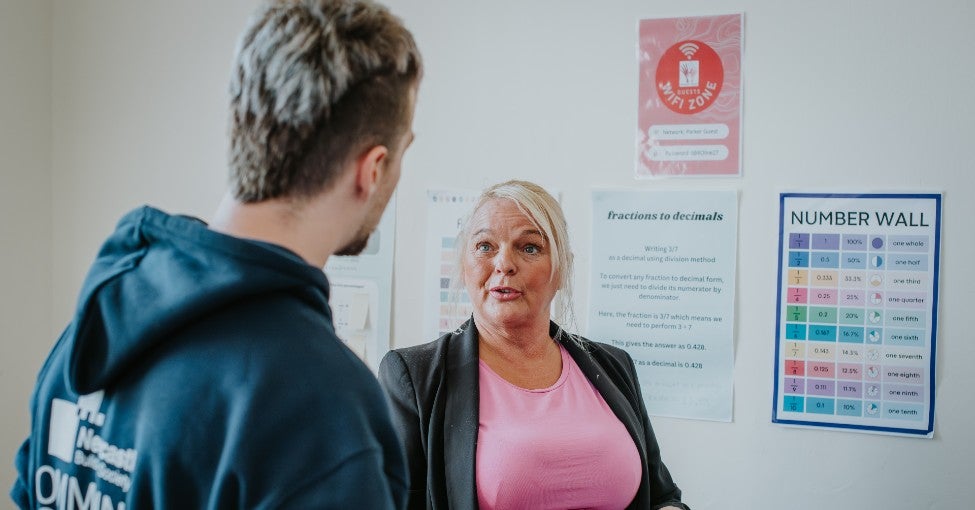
[657,40,724,114]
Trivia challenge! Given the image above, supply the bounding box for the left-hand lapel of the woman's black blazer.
[443,319,480,510]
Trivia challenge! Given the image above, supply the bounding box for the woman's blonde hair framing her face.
[454,180,575,329]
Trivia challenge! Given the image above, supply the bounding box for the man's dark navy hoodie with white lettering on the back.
[11,207,406,510]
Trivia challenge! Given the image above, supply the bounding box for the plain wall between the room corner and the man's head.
[52,0,257,322]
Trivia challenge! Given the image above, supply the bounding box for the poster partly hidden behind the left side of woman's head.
[423,190,480,341]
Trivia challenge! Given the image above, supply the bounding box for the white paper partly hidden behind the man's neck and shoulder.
[324,197,396,372]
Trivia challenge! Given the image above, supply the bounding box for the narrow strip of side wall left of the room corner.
[0,0,53,498]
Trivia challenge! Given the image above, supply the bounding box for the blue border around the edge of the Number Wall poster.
[772,193,943,436]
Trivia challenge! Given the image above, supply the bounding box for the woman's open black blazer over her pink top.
[379,319,689,510]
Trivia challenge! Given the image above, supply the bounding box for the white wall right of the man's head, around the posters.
[394,0,975,510]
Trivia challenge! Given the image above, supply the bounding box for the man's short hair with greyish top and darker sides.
[230,0,422,202]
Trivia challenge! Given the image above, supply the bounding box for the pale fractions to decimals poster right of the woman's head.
[586,190,738,421]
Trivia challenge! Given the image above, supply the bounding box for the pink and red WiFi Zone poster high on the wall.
[636,13,744,179]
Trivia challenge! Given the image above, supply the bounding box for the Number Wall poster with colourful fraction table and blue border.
[772,193,941,438]
